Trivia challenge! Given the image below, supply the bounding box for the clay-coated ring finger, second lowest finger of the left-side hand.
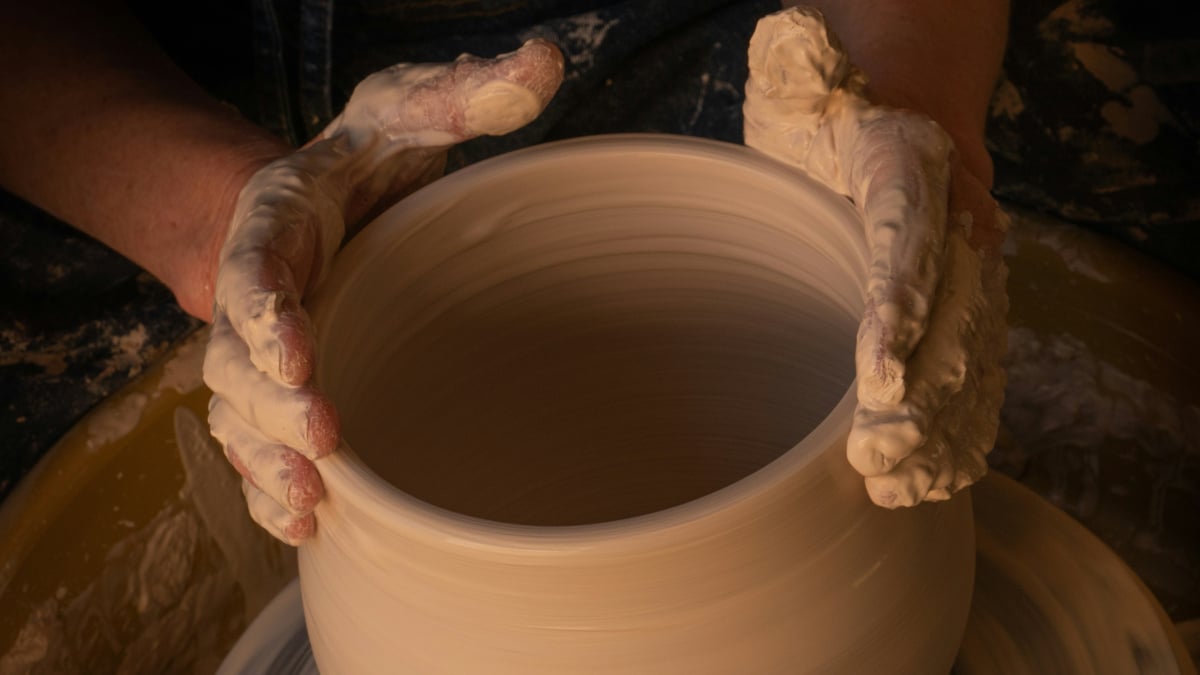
[209,396,325,515]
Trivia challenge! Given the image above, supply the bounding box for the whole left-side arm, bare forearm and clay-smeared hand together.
[0,0,563,543]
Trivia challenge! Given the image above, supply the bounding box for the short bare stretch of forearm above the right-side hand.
[785,0,1008,186]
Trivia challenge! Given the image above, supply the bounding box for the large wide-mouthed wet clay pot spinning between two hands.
[300,136,974,675]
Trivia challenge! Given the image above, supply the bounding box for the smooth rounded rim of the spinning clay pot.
[306,133,868,554]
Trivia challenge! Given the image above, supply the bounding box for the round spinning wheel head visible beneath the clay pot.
[220,472,1195,675]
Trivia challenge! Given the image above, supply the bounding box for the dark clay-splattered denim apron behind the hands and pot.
[0,0,1200,498]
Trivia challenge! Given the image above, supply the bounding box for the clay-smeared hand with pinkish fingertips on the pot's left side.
[204,41,563,544]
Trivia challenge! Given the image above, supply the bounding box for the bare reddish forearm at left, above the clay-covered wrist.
[0,0,288,318]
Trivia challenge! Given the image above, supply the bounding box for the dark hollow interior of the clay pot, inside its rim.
[320,138,860,525]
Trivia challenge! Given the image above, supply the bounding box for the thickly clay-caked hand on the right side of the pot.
[745,8,1008,507]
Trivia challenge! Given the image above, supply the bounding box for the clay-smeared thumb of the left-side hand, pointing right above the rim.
[324,40,563,148]
